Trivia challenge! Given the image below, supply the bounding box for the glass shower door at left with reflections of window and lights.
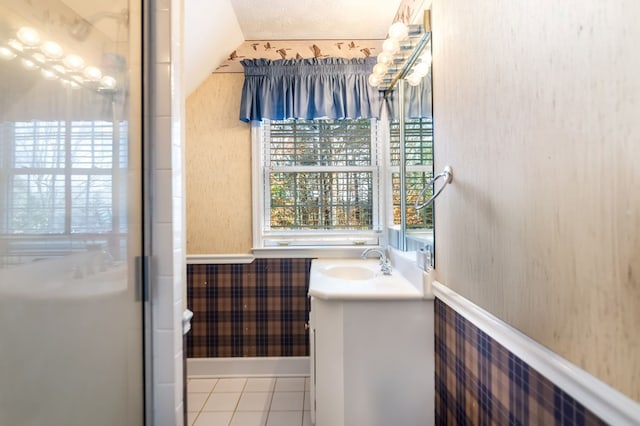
[0,0,144,426]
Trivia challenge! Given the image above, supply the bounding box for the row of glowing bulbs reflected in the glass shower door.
[0,27,118,92]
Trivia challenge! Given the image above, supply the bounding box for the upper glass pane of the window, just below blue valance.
[269,120,372,167]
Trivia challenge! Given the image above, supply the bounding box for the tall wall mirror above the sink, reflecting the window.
[385,11,434,255]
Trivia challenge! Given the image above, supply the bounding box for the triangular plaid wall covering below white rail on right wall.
[435,299,605,426]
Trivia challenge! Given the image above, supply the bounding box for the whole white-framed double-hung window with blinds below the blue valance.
[254,119,381,247]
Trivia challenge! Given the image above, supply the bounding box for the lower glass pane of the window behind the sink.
[270,172,373,230]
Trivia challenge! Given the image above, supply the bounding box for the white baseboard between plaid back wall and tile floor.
[187,356,309,377]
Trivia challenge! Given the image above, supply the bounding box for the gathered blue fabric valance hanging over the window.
[240,57,382,122]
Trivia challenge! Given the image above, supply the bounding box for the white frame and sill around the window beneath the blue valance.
[251,119,386,255]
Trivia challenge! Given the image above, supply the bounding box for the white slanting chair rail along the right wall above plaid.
[433,281,640,425]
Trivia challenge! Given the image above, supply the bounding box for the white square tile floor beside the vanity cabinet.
[187,377,311,426]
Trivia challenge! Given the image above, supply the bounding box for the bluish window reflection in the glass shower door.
[0,121,127,235]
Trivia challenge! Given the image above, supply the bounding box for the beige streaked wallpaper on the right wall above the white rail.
[432,0,640,401]
